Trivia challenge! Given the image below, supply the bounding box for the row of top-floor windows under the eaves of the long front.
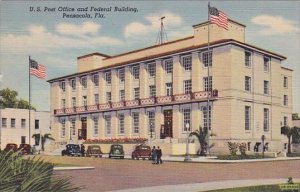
[60,52,212,92]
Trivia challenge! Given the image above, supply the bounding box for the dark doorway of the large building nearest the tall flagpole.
[160,109,173,139]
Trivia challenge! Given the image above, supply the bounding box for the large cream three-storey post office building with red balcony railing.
[48,20,292,152]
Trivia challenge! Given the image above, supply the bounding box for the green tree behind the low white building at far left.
[0,88,18,108]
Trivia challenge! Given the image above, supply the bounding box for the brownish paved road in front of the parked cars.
[41,156,300,192]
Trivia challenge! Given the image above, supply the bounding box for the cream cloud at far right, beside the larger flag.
[251,15,300,35]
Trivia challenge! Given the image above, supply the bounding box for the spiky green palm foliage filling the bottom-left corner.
[0,151,80,192]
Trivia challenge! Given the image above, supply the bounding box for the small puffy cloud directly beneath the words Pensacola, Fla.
[56,21,101,36]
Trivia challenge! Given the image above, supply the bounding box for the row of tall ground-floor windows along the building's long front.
[60,107,211,137]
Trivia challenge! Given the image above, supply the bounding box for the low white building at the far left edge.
[0,108,50,149]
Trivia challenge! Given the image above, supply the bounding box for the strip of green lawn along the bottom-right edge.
[209,185,299,192]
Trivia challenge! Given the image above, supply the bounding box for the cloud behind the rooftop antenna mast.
[124,11,182,38]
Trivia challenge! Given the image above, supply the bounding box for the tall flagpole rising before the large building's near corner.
[206,2,211,155]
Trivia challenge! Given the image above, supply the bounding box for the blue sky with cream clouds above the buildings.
[0,0,300,113]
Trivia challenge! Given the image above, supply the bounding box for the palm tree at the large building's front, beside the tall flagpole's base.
[189,126,215,156]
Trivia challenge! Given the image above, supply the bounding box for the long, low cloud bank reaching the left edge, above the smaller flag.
[0,23,123,54]
